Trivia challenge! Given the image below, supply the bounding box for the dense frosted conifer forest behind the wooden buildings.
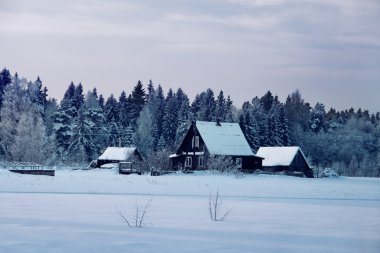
[0,68,380,177]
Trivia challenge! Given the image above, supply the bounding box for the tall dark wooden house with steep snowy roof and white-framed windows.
[169,121,262,172]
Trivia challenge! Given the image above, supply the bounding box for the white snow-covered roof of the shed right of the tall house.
[256,147,303,166]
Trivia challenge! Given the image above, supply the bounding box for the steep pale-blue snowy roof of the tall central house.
[196,121,254,156]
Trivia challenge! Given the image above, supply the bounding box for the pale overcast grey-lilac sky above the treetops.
[0,0,380,112]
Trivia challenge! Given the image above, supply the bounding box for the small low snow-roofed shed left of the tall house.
[96,147,143,168]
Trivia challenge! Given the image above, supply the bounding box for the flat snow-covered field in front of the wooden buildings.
[0,170,380,253]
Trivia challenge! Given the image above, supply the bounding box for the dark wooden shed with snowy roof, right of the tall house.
[256,147,314,177]
